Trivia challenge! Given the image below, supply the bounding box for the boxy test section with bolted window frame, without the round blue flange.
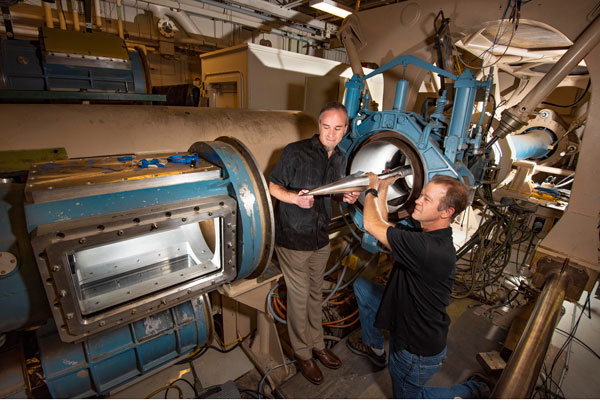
[25,155,237,341]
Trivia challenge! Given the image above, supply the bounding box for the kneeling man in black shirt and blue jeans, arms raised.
[347,173,489,398]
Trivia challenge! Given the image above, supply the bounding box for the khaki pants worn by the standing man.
[275,244,331,360]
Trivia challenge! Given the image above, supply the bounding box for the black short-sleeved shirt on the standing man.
[269,135,346,251]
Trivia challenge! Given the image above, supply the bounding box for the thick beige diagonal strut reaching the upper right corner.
[486,16,600,149]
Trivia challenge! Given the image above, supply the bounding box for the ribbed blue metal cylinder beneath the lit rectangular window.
[37,295,212,398]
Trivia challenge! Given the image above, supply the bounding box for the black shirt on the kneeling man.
[375,225,456,356]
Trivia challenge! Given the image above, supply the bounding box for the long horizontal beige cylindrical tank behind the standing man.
[0,104,317,173]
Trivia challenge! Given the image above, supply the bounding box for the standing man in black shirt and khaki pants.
[269,102,359,384]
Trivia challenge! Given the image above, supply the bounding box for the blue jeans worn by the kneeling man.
[354,277,490,398]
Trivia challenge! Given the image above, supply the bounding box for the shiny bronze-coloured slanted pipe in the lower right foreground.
[491,271,570,398]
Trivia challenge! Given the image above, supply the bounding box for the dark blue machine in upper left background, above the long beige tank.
[0,27,165,101]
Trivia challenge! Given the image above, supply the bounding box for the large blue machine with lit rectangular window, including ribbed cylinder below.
[0,137,274,398]
